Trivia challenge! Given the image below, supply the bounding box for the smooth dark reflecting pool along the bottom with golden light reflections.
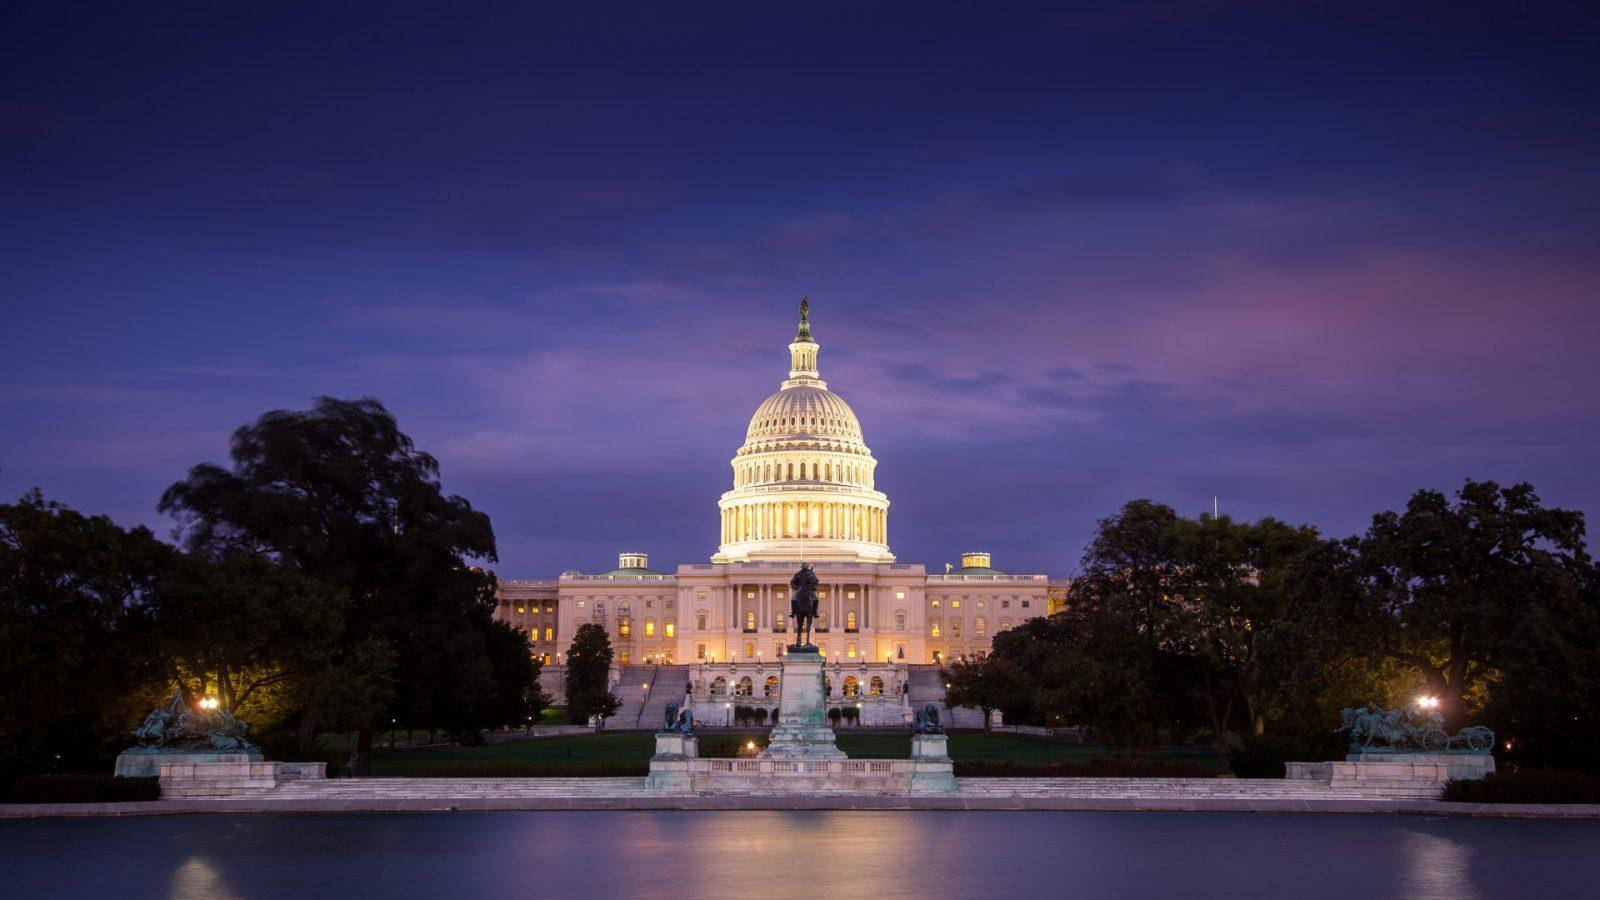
[0,812,1600,900]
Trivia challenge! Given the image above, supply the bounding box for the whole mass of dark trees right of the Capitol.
[946,480,1600,775]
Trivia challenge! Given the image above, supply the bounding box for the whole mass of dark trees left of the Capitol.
[0,397,547,781]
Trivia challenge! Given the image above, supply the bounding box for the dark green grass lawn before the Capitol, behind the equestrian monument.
[360,729,1216,775]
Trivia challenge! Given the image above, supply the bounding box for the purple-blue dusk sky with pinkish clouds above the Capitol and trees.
[0,0,1600,577]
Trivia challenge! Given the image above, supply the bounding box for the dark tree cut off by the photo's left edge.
[0,490,174,788]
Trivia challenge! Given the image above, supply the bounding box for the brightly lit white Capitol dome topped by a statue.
[712,301,894,562]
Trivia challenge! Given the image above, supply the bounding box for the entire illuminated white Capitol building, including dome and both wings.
[496,303,1066,724]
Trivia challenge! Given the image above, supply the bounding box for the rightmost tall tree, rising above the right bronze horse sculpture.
[1352,480,1590,719]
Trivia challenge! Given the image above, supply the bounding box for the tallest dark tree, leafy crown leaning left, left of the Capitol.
[160,397,496,769]
